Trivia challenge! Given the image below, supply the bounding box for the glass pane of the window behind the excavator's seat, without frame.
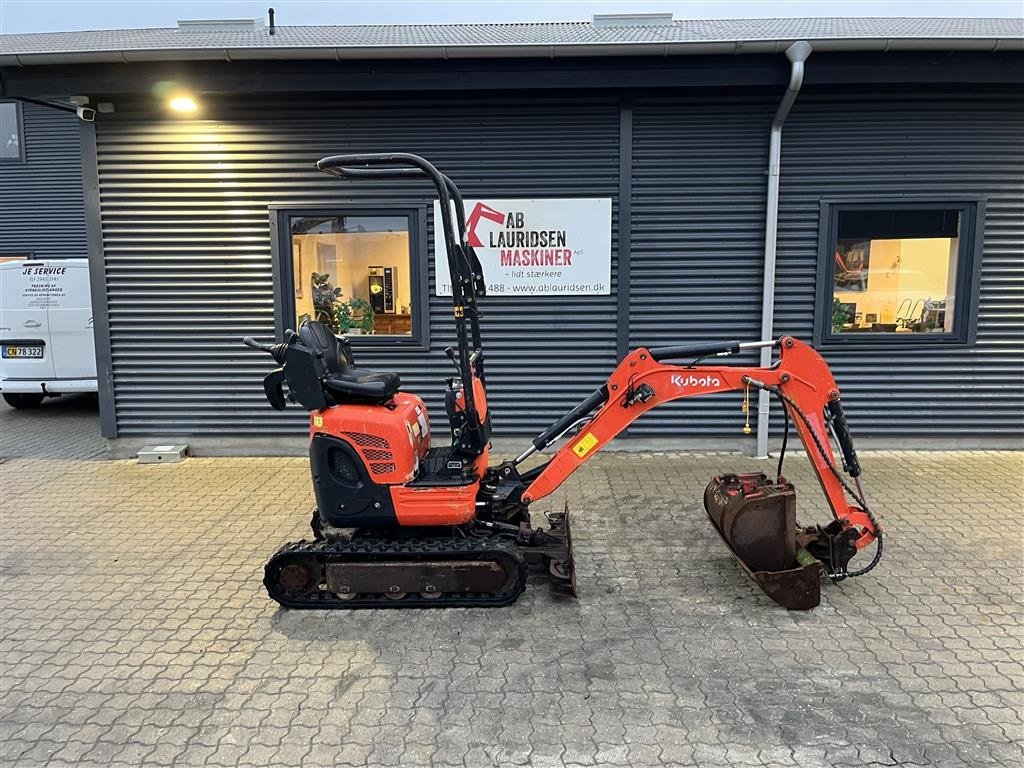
[290,214,414,337]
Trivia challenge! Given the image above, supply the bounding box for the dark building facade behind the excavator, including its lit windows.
[3,15,1024,445]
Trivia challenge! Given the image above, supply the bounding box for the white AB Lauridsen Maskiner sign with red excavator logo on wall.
[434,198,611,296]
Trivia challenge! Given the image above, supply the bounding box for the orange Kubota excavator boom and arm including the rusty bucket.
[522,337,881,608]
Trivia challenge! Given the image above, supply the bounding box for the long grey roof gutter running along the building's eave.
[0,35,1024,67]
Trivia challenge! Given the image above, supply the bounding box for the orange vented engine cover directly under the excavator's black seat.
[309,392,430,485]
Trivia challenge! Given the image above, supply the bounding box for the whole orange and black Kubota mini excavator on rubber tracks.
[244,154,882,609]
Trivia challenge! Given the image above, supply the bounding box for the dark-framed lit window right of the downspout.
[817,201,980,343]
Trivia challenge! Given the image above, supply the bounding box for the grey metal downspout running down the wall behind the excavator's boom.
[755,40,812,459]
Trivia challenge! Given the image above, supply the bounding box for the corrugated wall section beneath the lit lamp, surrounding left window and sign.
[96,95,618,435]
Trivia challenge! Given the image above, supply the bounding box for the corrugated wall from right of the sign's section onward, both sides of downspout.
[630,92,1024,437]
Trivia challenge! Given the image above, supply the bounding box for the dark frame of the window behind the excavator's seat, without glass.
[269,200,430,351]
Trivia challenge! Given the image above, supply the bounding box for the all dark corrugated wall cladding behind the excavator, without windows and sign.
[97,91,1024,437]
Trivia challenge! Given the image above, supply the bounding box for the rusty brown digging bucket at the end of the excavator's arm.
[705,473,823,610]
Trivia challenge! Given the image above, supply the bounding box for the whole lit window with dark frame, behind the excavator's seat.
[278,209,427,344]
